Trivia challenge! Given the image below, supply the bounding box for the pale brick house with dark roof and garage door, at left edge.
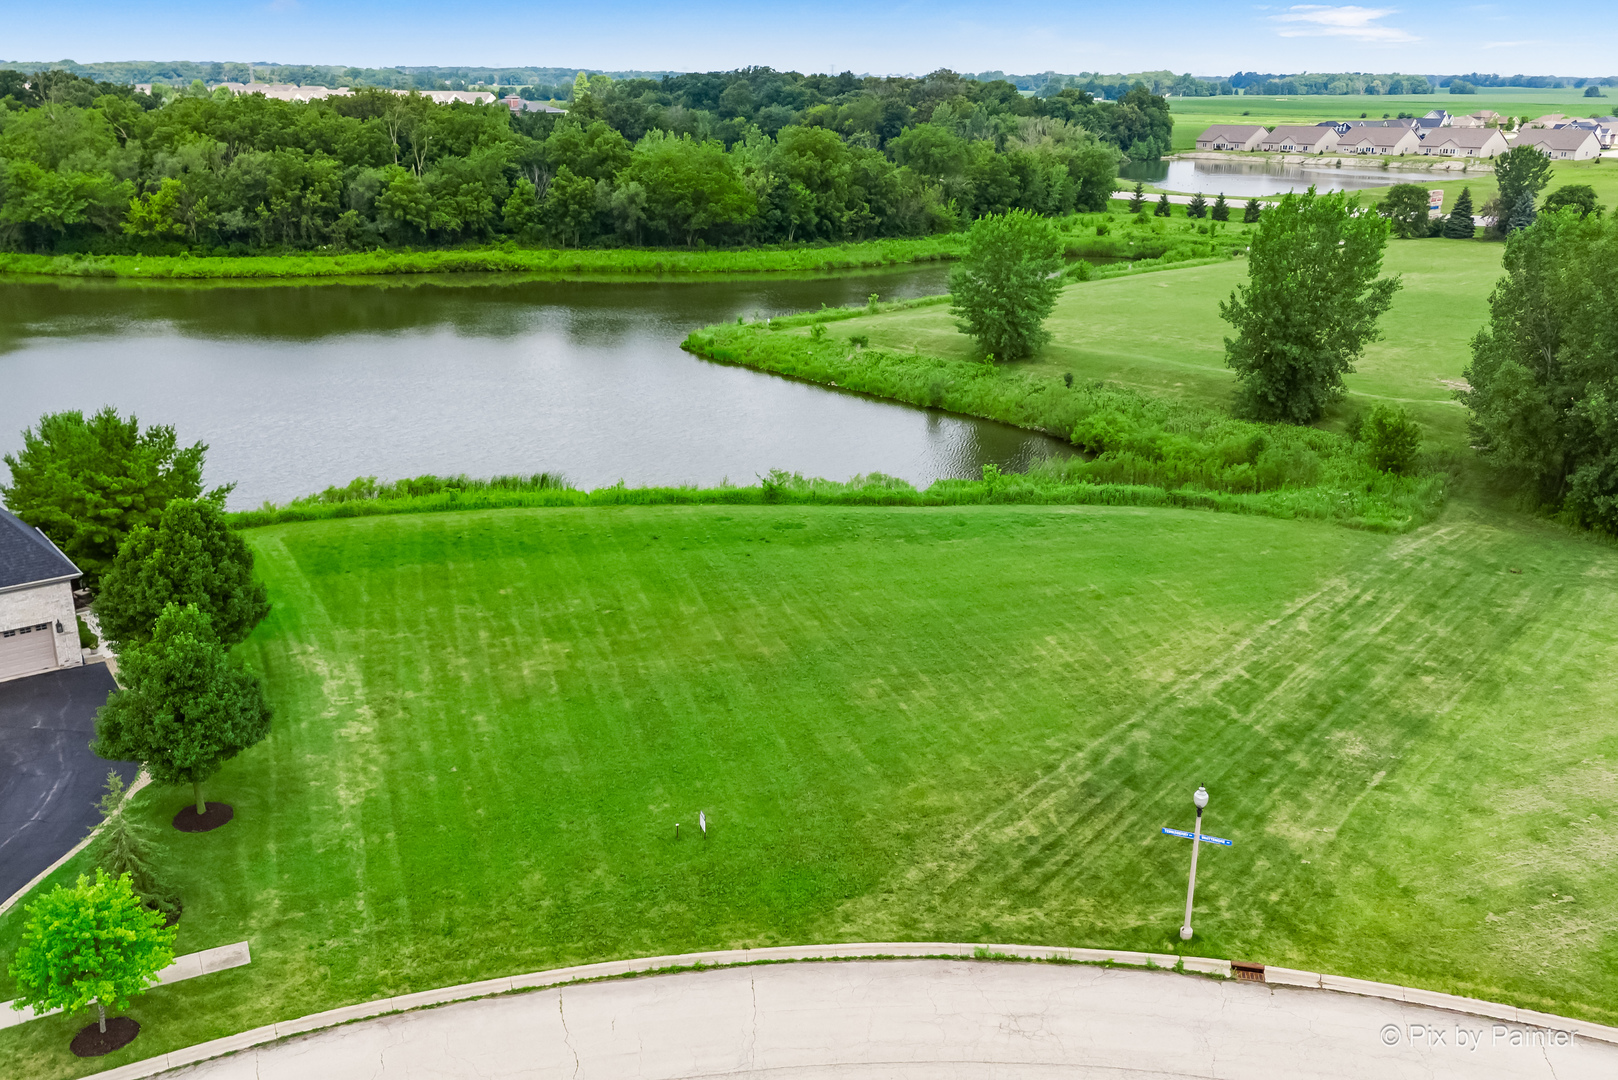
[0,510,84,680]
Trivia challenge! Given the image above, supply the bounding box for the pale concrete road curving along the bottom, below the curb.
[172,960,1618,1080]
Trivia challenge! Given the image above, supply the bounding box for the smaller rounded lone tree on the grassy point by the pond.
[950,210,1063,359]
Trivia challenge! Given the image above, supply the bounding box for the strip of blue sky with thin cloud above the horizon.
[0,0,1618,74]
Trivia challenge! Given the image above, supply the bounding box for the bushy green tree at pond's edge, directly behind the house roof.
[0,406,231,588]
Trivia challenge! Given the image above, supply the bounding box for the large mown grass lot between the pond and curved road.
[0,507,1618,1077]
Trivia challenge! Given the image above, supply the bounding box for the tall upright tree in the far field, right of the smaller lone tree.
[1220,188,1400,424]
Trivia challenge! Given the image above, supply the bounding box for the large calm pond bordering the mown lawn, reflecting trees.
[0,266,1068,508]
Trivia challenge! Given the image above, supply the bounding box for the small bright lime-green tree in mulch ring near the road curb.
[11,870,175,1057]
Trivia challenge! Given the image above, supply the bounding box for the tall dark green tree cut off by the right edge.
[1458,214,1618,531]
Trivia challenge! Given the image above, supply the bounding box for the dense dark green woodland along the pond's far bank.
[0,68,1173,254]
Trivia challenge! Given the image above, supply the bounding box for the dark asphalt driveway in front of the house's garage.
[0,664,138,902]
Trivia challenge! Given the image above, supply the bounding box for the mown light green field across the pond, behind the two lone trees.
[809,238,1501,449]
